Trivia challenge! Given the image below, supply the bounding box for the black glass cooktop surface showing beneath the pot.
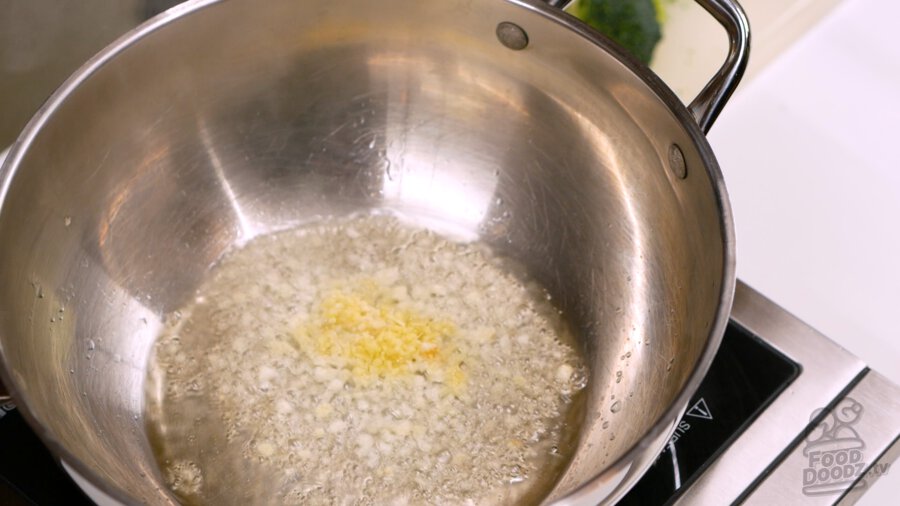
[0,323,800,506]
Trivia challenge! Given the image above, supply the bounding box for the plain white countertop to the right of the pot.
[710,0,900,505]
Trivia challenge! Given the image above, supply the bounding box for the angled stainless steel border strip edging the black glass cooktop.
[677,282,865,505]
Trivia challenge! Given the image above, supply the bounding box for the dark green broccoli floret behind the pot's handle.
[569,0,662,63]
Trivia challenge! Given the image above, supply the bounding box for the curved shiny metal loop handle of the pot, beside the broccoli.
[545,0,750,133]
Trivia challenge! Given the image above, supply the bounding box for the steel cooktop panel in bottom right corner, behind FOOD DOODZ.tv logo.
[744,371,900,506]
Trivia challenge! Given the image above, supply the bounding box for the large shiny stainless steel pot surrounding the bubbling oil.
[0,0,748,504]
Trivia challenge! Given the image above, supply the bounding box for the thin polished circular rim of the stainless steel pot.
[0,0,736,505]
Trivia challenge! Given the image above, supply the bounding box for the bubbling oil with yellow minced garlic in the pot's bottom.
[145,215,586,505]
